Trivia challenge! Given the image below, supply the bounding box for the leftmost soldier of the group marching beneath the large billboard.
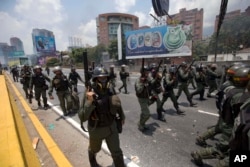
[135,66,152,131]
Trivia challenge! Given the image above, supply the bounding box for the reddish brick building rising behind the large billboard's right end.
[167,8,203,41]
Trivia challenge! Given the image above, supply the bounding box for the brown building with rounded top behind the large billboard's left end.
[96,13,139,46]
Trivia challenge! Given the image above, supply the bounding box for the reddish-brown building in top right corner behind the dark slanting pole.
[214,6,250,32]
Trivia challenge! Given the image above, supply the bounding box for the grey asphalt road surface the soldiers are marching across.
[9,69,221,167]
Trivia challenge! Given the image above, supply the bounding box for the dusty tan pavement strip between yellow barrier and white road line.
[4,72,112,167]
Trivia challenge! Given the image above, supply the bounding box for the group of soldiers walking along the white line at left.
[11,65,84,116]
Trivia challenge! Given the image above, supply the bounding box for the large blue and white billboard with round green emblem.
[125,25,192,59]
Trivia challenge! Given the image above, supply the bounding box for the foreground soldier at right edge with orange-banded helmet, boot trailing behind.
[191,68,249,166]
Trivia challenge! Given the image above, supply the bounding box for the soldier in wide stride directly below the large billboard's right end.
[176,62,197,107]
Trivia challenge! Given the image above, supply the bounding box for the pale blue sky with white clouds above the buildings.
[0,0,250,54]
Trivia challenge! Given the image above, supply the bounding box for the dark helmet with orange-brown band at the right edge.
[233,67,250,88]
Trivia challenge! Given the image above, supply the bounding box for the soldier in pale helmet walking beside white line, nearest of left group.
[48,66,72,116]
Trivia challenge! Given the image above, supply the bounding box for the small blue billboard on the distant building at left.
[35,36,56,52]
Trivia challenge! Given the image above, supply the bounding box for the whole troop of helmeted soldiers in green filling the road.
[9,62,250,167]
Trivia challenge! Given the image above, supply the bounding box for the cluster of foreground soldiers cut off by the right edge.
[191,63,250,167]
